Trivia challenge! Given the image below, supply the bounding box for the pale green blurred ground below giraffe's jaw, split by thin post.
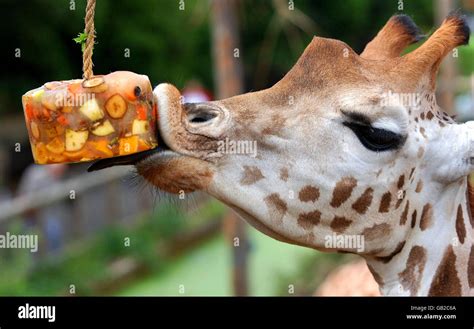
[117,228,341,296]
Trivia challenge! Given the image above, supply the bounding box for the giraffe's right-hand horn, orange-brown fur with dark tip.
[400,12,470,88]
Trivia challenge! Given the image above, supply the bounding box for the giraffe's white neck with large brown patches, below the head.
[366,179,474,296]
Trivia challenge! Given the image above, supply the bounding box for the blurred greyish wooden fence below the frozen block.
[0,167,155,256]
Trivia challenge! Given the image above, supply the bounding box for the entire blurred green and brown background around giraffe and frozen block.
[0,0,474,296]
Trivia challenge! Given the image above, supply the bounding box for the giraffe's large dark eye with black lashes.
[344,122,404,152]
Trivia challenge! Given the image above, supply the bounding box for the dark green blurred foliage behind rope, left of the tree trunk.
[0,0,212,113]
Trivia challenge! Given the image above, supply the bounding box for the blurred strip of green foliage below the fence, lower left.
[0,201,226,296]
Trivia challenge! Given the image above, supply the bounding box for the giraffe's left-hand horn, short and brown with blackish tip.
[360,15,424,60]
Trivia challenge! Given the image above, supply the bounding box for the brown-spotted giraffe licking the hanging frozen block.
[91,13,474,296]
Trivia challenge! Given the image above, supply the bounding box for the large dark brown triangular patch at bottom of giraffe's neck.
[428,245,461,296]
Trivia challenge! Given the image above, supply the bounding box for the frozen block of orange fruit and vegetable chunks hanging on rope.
[22,71,157,164]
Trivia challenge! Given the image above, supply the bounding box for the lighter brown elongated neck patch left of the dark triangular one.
[398,246,426,296]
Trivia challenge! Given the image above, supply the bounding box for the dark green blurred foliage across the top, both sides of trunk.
[0,0,462,114]
